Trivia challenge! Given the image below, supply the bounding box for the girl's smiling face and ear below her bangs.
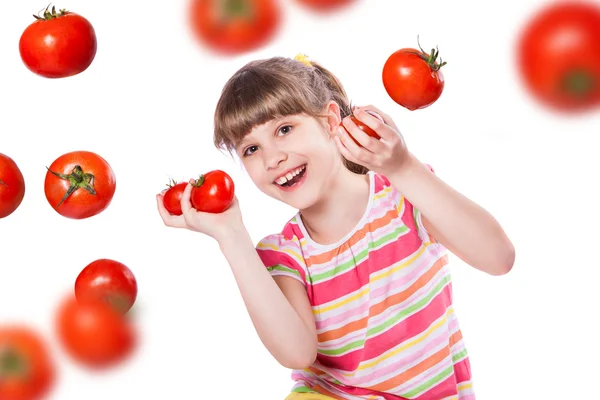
[236,103,344,210]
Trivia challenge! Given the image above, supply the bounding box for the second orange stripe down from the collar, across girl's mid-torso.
[318,259,445,343]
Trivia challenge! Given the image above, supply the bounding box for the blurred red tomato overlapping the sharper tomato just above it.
[55,296,137,368]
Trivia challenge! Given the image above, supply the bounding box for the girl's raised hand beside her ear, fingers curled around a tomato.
[335,106,409,176]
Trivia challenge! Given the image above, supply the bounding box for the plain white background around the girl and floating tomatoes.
[0,0,600,400]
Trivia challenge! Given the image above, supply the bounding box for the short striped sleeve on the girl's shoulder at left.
[256,234,308,287]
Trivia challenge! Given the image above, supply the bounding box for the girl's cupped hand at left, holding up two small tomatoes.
[156,180,244,241]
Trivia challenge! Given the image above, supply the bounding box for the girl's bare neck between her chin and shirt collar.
[300,167,369,245]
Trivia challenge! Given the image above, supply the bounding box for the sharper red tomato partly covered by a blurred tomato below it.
[75,259,137,314]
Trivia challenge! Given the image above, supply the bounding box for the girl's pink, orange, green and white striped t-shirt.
[257,172,475,400]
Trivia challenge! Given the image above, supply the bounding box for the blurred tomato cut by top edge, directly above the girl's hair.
[190,0,281,55]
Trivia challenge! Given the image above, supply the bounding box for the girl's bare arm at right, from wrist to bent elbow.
[387,154,515,275]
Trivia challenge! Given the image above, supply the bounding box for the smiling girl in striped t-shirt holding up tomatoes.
[157,57,514,400]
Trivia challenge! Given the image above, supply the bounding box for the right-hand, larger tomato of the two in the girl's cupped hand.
[191,170,235,213]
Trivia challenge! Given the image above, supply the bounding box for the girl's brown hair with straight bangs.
[214,57,368,174]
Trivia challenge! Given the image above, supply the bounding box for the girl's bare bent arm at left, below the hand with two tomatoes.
[219,229,317,369]
